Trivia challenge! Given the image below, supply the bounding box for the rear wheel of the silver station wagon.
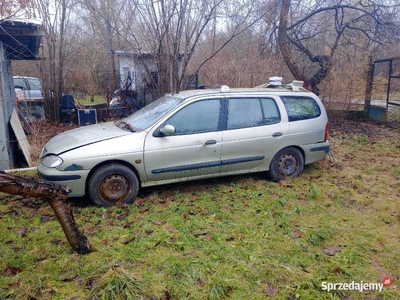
[269,147,304,182]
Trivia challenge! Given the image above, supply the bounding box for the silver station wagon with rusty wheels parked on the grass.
[38,83,329,206]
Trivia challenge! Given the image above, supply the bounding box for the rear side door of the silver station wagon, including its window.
[221,97,288,173]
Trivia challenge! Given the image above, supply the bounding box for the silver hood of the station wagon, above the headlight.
[41,122,132,156]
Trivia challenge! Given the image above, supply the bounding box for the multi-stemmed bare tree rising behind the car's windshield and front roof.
[81,0,264,94]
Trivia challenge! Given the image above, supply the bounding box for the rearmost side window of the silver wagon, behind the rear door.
[281,96,321,122]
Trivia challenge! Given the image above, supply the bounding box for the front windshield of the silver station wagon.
[115,96,183,131]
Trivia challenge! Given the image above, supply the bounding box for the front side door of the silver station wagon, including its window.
[144,99,222,181]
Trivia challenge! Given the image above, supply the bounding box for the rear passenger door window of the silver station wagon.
[227,98,280,130]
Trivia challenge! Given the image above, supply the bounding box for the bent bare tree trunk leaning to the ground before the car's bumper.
[0,171,92,254]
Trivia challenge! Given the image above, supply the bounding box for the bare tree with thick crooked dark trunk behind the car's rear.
[277,0,400,93]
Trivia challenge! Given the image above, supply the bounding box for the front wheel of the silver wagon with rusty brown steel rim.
[88,163,139,207]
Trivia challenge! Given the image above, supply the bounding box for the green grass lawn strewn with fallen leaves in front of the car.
[0,121,400,299]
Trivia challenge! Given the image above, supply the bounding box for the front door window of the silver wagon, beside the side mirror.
[166,99,220,135]
